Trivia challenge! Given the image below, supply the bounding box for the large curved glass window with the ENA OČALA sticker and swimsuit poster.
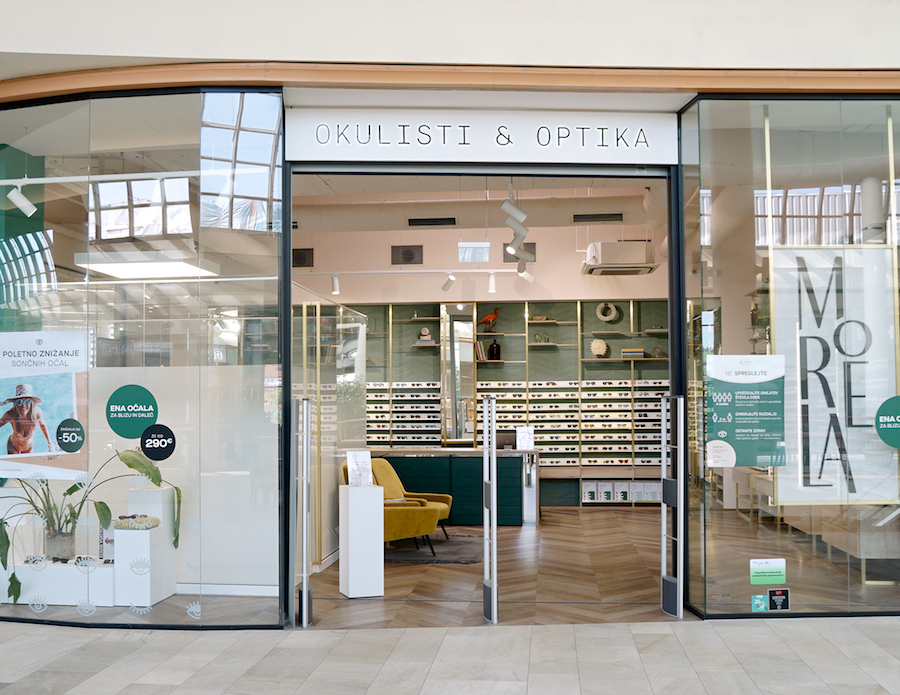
[0,92,281,626]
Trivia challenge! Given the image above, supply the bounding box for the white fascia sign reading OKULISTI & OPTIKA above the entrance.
[285,107,678,166]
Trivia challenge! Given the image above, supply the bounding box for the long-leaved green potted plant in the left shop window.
[0,451,181,603]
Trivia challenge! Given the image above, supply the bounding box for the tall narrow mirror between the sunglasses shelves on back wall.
[441,303,475,445]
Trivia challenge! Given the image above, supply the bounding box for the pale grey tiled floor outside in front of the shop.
[0,617,900,695]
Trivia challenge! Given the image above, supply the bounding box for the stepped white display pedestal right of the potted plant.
[113,487,176,606]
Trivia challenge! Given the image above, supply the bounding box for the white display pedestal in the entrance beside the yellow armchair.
[339,485,384,598]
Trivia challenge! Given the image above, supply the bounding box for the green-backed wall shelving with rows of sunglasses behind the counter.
[352,300,669,505]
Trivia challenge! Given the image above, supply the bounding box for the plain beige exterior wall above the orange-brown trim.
[3,0,900,74]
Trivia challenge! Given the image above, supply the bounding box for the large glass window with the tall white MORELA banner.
[683,99,900,615]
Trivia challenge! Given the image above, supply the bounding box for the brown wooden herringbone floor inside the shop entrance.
[313,507,669,629]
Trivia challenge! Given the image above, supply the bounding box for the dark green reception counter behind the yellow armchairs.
[369,447,538,526]
